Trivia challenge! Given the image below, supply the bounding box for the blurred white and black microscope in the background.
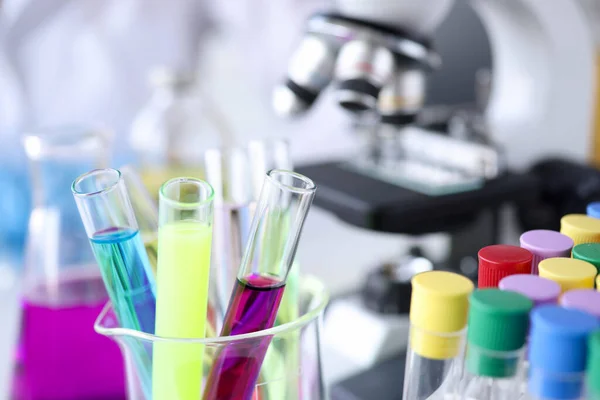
[273,0,600,400]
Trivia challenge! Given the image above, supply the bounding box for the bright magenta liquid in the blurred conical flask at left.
[14,267,126,400]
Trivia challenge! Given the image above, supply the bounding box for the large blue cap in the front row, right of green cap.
[528,305,600,399]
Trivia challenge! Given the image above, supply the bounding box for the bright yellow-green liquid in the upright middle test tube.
[152,221,212,400]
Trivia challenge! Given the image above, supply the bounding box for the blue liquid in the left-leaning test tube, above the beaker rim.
[90,228,156,334]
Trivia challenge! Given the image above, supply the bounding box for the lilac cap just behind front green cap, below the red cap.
[498,274,560,306]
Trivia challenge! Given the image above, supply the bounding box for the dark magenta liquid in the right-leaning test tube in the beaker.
[204,275,285,400]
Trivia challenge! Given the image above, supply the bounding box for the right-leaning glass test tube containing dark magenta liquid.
[203,170,316,400]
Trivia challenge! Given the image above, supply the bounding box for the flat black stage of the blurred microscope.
[297,162,539,235]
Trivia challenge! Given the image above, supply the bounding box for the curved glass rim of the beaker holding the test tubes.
[94,275,329,345]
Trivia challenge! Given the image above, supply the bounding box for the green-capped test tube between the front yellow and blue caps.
[460,289,533,400]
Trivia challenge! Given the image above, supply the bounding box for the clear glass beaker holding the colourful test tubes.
[95,277,329,400]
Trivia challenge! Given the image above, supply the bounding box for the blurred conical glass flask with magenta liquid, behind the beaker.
[15,128,125,400]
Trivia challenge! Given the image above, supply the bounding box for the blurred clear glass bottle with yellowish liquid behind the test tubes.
[129,68,230,198]
